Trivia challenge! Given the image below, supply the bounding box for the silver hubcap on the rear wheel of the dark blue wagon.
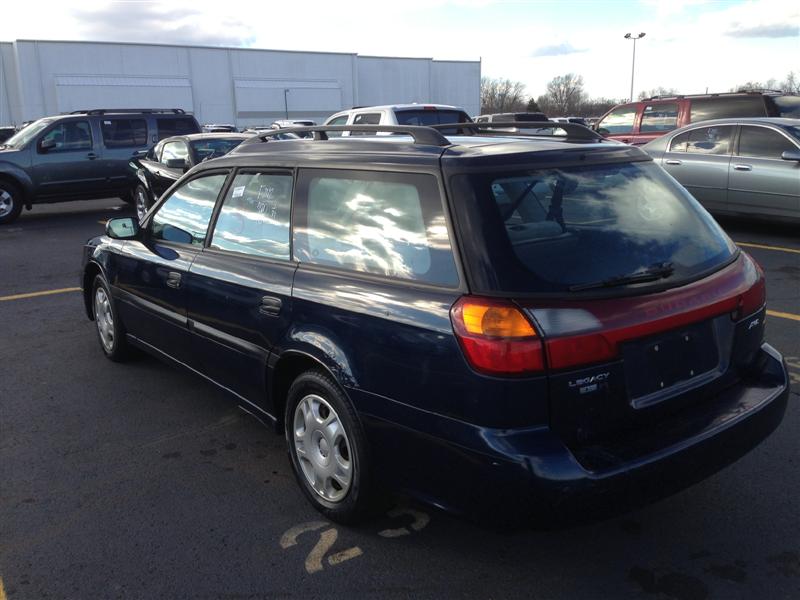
[294,394,353,502]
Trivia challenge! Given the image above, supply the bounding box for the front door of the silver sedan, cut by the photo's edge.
[728,125,800,218]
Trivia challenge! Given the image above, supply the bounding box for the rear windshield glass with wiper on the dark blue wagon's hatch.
[453,161,736,294]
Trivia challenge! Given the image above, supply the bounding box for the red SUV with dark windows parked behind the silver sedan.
[594,91,800,146]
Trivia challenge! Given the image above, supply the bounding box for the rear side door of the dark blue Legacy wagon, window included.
[188,168,296,411]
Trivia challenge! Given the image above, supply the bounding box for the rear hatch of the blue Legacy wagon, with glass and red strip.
[450,152,765,454]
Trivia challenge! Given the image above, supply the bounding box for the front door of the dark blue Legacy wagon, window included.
[111,171,228,366]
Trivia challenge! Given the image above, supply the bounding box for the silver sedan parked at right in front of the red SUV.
[642,117,800,221]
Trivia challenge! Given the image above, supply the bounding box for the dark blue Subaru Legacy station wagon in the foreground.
[82,124,788,522]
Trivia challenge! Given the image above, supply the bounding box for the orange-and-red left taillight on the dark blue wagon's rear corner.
[450,296,544,375]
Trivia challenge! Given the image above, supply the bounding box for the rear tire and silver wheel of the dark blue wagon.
[284,371,371,524]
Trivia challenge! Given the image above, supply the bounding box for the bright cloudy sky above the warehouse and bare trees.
[0,0,800,98]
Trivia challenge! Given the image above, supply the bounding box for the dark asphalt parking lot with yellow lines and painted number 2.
[0,200,800,600]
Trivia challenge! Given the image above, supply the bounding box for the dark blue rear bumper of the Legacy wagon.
[354,344,789,526]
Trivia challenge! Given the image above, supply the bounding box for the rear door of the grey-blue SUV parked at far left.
[99,117,149,193]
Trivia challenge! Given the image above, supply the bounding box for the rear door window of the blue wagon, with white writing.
[211,173,292,259]
